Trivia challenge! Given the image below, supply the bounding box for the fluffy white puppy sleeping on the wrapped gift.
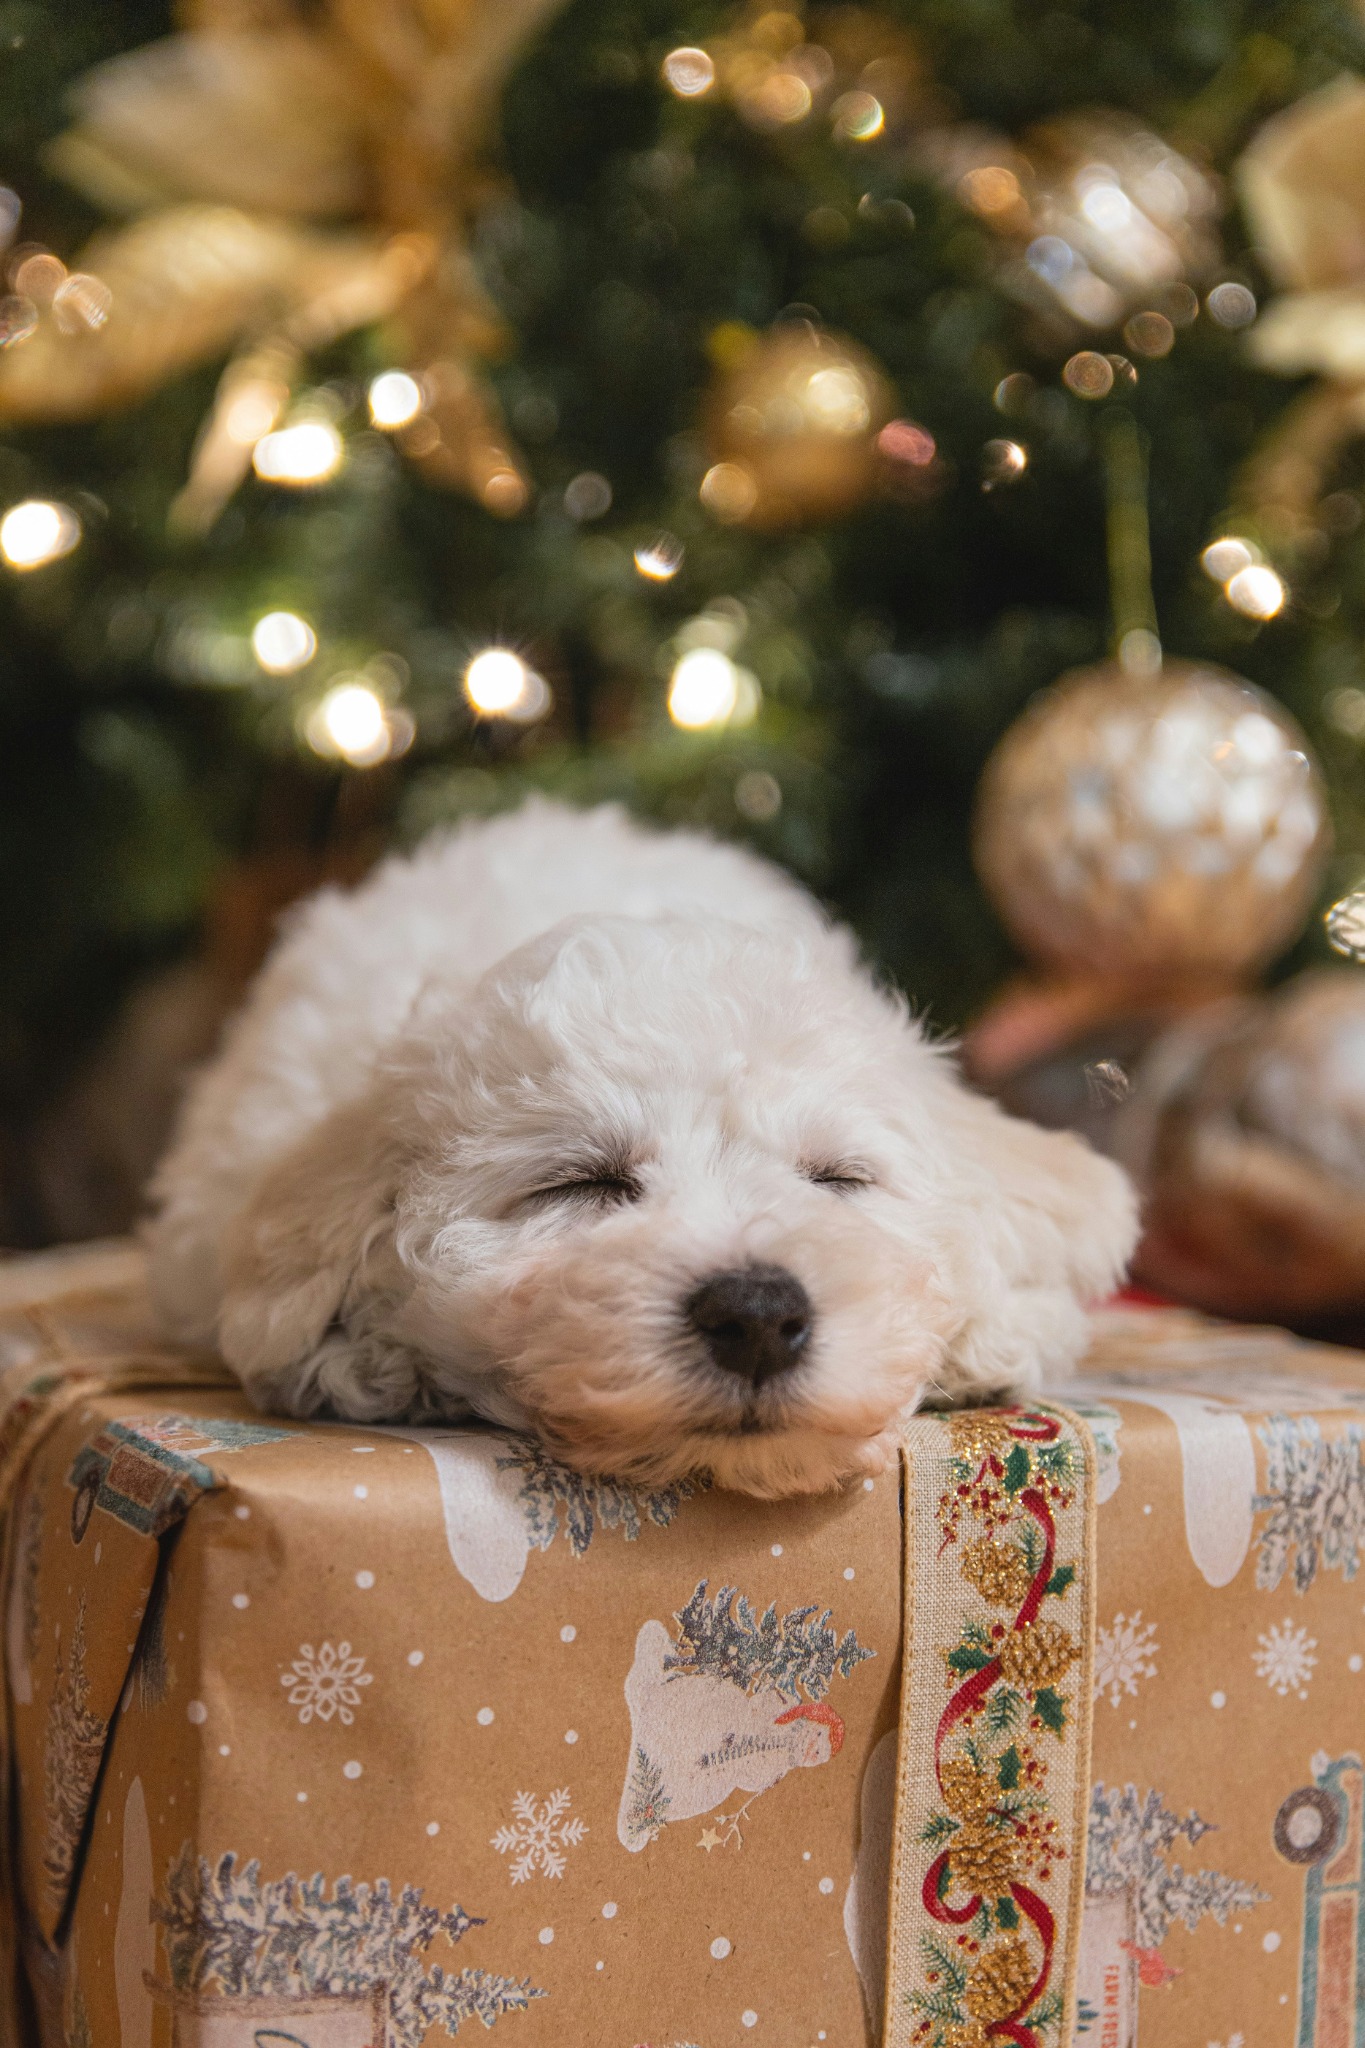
[149,803,1136,1497]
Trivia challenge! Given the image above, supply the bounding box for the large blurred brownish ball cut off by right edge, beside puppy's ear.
[1111,969,1365,1321]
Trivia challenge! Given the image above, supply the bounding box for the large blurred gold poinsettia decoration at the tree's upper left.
[0,0,563,530]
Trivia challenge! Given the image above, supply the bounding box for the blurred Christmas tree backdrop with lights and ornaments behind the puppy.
[0,0,1365,1335]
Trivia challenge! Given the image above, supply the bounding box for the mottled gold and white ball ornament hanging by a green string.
[974,662,1328,981]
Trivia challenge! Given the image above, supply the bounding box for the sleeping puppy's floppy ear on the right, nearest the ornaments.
[943,1085,1138,1395]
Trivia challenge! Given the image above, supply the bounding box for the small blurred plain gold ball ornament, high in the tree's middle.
[706,322,892,526]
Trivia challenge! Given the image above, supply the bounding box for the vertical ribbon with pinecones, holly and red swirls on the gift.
[882,1403,1095,2048]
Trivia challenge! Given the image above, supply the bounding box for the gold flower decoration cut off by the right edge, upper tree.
[1236,76,1365,541]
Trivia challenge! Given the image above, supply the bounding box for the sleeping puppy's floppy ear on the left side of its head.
[219,1090,401,1413]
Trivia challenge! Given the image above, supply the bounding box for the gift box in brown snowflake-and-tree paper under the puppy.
[0,1247,1365,2048]
